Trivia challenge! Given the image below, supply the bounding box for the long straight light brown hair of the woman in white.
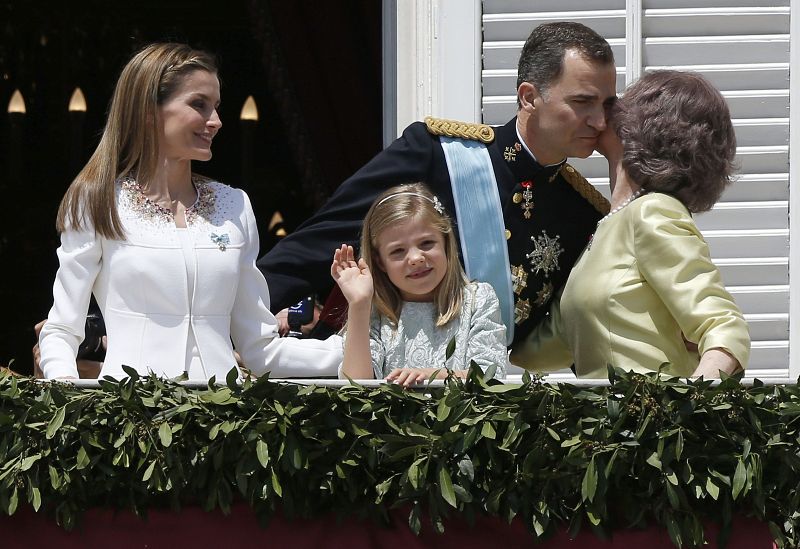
[56,43,217,240]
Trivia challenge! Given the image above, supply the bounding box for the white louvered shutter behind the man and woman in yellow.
[482,0,800,379]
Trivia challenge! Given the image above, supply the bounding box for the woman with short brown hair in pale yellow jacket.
[511,71,750,377]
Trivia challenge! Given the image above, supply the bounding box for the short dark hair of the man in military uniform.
[517,21,614,93]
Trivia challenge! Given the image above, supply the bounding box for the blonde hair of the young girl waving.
[361,183,468,326]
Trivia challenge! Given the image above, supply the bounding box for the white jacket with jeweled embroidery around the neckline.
[39,179,342,380]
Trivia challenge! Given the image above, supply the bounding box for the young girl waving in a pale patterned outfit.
[331,183,508,387]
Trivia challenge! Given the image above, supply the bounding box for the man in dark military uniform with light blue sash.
[258,23,616,356]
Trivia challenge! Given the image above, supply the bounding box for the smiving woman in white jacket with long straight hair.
[39,43,341,380]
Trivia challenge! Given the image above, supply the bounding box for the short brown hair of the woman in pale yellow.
[612,71,736,212]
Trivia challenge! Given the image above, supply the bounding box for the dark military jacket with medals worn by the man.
[258,118,608,342]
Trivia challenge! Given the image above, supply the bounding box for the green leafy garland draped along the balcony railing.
[0,369,800,547]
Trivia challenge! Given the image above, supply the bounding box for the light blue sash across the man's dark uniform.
[439,136,514,345]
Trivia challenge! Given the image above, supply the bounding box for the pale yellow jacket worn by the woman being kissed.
[511,193,750,378]
